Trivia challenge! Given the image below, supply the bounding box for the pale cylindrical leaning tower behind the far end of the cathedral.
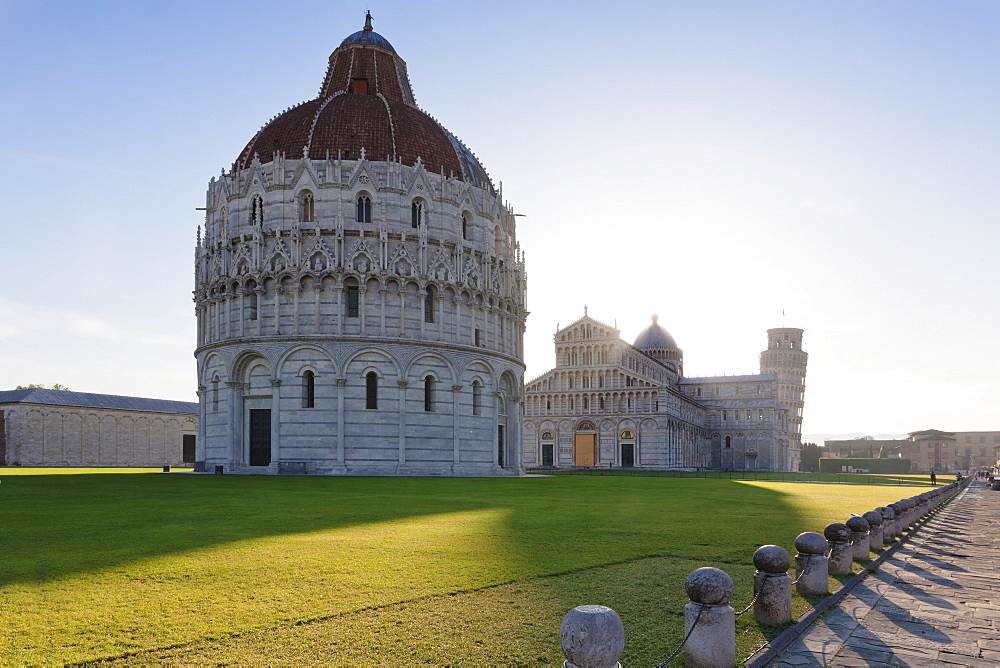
[760,327,809,471]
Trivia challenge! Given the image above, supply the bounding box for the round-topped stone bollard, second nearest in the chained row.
[684,567,736,668]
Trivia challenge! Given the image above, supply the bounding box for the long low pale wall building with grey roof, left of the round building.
[0,389,198,466]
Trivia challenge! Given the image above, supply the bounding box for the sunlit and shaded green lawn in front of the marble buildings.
[0,469,913,665]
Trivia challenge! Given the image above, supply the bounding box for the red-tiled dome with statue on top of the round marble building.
[233,14,494,193]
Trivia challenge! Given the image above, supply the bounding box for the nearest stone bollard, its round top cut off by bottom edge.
[559,605,625,668]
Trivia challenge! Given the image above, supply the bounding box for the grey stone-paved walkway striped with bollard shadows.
[769,482,1000,666]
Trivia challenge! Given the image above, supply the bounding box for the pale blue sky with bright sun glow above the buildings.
[0,0,1000,434]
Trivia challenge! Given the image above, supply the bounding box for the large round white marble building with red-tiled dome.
[194,14,527,476]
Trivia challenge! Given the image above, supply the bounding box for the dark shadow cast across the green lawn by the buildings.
[0,474,860,663]
